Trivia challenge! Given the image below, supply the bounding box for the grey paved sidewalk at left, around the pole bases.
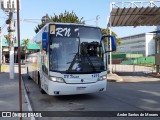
[0,66,30,120]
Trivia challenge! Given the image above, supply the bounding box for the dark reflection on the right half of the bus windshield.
[68,42,104,72]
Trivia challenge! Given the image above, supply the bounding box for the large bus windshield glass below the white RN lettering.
[49,27,105,74]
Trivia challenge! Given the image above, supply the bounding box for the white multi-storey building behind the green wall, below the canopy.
[118,33,155,56]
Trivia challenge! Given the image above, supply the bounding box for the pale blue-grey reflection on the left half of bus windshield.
[50,38,78,71]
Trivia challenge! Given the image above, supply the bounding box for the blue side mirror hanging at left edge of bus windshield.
[42,32,48,51]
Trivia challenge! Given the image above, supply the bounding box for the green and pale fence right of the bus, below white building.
[109,54,156,74]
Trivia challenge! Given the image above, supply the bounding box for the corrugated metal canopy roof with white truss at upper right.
[109,1,160,27]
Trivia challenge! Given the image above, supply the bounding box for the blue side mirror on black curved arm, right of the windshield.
[101,35,117,53]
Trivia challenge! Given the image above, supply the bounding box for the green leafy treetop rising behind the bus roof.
[35,11,85,33]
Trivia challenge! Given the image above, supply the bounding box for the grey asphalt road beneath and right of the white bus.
[23,75,160,120]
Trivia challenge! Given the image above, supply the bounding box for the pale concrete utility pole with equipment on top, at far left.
[0,0,17,79]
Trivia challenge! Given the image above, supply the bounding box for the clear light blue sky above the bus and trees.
[0,0,155,39]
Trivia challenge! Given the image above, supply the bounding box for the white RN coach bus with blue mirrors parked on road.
[26,23,116,95]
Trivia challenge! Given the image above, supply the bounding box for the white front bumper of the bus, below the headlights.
[46,80,107,96]
